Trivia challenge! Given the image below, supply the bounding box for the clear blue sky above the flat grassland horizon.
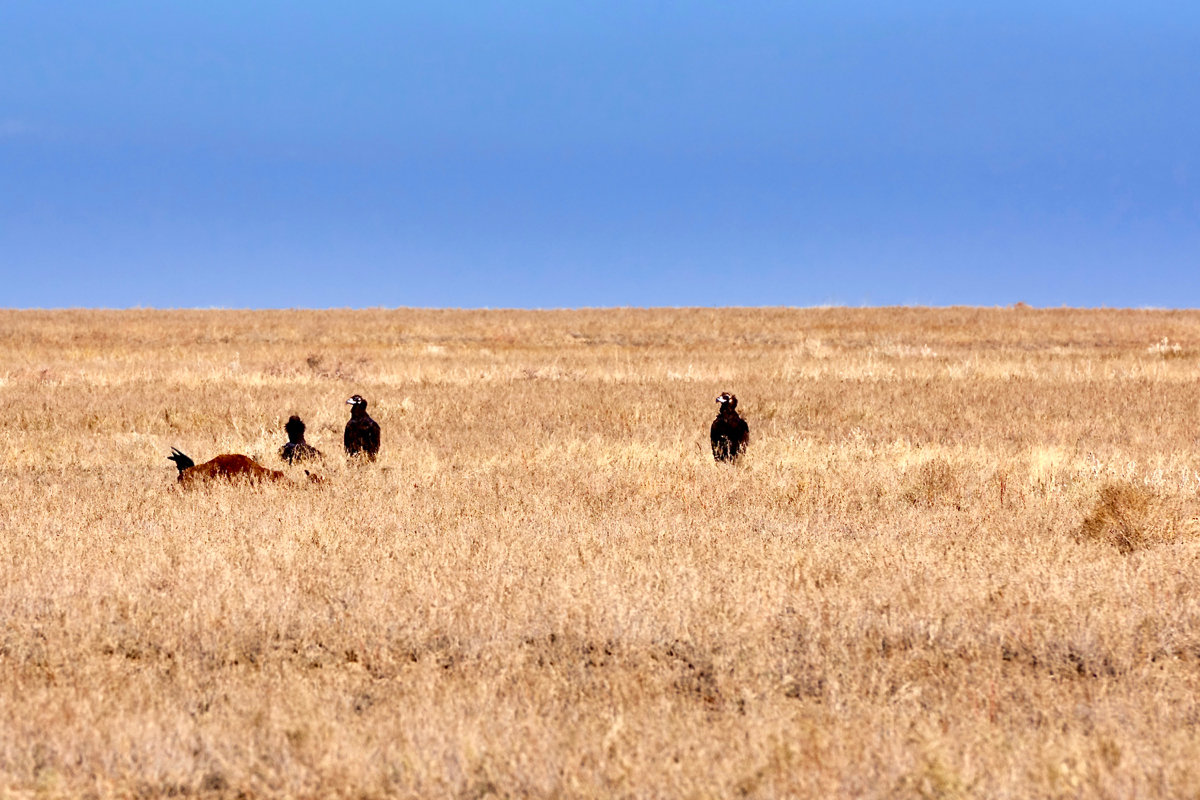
[0,0,1200,307]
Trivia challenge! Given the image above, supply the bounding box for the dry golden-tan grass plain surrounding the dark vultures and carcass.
[0,308,1200,798]
